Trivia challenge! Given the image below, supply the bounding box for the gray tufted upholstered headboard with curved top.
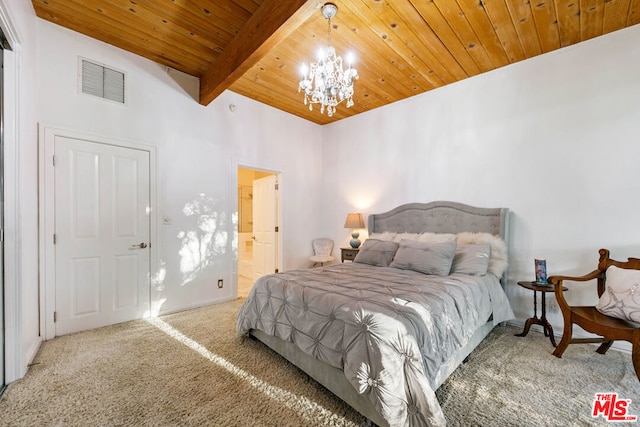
[368,202,509,242]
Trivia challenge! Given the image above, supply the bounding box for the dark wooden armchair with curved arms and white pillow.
[547,249,640,380]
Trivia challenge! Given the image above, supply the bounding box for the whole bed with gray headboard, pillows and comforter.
[237,202,513,426]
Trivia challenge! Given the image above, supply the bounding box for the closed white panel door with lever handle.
[55,137,150,335]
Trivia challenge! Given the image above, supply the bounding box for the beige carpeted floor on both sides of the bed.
[0,300,640,426]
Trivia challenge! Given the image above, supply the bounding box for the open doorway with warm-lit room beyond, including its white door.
[237,167,279,298]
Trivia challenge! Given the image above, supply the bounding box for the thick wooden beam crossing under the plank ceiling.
[200,0,322,105]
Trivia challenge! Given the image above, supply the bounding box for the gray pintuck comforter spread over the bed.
[237,264,514,426]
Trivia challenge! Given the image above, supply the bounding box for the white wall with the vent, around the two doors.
[33,20,322,313]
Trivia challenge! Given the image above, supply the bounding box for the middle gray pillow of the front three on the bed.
[389,240,456,276]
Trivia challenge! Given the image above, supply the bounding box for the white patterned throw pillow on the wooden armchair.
[596,265,640,323]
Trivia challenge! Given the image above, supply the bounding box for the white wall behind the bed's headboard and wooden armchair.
[323,25,640,332]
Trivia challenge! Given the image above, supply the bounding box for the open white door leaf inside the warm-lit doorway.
[253,175,278,281]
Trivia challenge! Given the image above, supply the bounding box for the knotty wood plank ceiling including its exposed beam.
[32,0,640,124]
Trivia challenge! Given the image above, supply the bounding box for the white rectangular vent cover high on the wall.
[80,59,124,104]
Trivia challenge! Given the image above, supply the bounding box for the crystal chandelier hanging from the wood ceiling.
[298,3,358,117]
